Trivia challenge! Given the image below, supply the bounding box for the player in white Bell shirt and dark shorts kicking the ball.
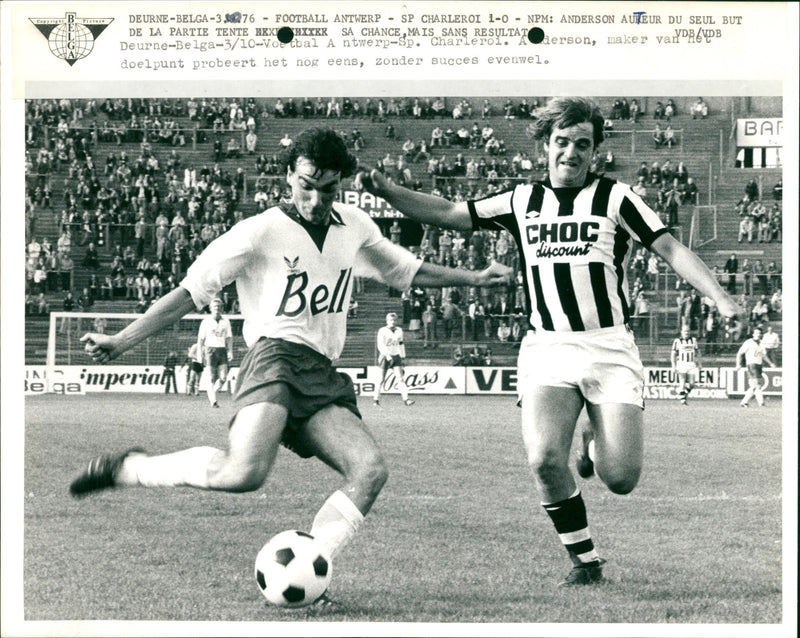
[70,129,512,604]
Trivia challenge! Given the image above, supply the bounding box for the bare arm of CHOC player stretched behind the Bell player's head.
[355,169,472,230]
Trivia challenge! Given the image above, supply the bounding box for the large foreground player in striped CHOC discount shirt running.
[357,97,738,585]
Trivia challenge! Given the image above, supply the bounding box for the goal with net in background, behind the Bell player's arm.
[46,312,247,390]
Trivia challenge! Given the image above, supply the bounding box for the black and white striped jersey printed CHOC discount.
[468,173,667,332]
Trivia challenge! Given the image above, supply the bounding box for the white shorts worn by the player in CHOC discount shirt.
[517,326,644,407]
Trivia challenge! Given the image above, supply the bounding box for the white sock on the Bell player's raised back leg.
[116,447,219,489]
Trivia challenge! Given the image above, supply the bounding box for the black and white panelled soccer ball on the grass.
[255,530,332,607]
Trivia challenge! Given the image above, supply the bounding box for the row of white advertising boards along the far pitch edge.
[25,366,783,400]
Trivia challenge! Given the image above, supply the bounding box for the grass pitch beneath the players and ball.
[23,394,782,635]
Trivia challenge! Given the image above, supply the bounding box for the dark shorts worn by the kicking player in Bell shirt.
[234,337,361,458]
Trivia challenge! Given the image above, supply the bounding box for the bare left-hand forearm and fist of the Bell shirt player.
[81,286,195,363]
